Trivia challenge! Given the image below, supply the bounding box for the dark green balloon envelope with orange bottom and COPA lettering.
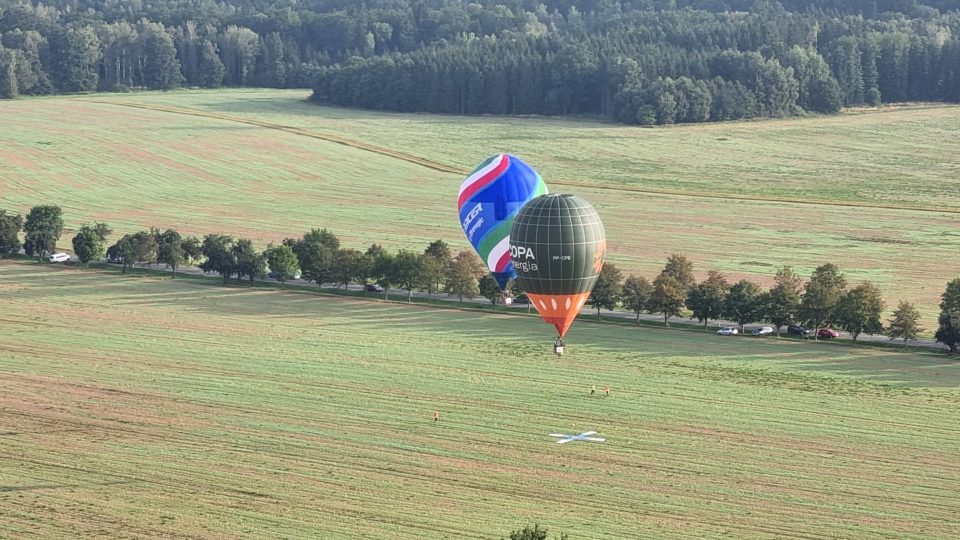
[510,194,607,337]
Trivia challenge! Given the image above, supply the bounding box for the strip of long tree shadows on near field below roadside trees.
[0,266,960,387]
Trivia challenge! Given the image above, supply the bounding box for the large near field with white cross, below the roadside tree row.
[0,261,960,539]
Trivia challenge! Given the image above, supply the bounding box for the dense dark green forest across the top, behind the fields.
[0,0,960,124]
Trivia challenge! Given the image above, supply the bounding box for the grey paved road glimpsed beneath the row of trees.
[101,264,947,350]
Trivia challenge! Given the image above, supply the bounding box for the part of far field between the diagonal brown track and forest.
[86,90,960,211]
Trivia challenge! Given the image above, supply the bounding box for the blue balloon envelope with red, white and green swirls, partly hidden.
[457,154,547,289]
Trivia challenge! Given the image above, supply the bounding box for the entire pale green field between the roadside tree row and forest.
[0,90,960,330]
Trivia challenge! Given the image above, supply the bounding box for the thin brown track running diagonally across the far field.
[78,99,960,214]
